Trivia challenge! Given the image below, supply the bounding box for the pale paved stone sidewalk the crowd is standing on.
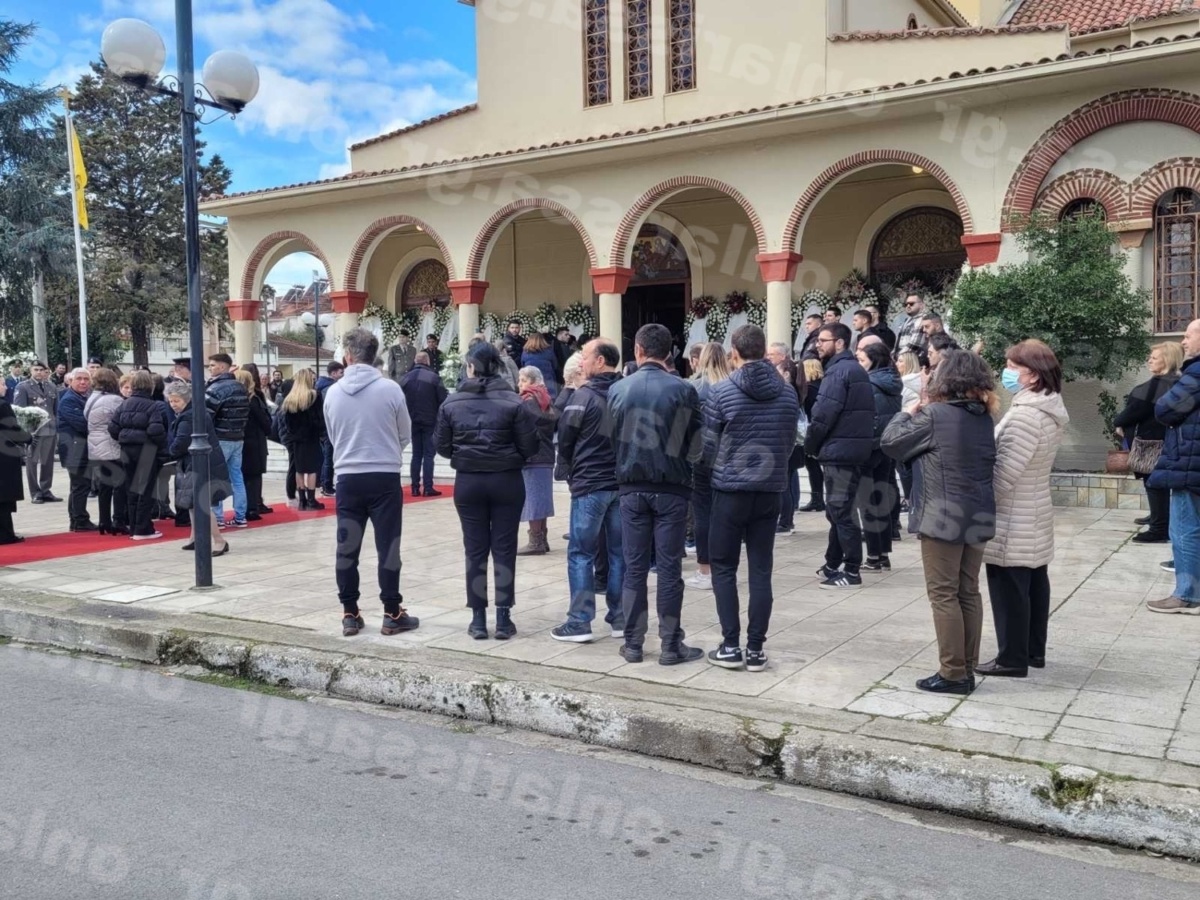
[0,481,1200,856]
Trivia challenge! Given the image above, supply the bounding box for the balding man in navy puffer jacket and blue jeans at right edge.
[1146,319,1200,616]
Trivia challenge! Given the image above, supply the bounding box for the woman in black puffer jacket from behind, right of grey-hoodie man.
[434,343,539,641]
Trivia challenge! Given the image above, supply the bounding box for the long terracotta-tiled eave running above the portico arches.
[202,31,1200,200]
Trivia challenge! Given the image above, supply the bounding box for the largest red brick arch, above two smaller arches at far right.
[1001,88,1200,232]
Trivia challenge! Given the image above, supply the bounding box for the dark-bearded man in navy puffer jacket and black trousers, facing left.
[804,322,875,589]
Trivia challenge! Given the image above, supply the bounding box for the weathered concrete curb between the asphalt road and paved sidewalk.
[7,600,1200,859]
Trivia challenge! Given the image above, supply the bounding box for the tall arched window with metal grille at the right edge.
[1154,188,1200,332]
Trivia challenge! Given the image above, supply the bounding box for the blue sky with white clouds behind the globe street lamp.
[9,0,476,283]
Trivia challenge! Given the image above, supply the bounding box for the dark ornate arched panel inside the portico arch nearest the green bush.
[870,206,967,296]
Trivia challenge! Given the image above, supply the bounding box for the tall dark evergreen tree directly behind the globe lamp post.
[72,64,230,365]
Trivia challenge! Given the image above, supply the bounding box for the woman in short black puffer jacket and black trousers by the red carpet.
[108,371,168,541]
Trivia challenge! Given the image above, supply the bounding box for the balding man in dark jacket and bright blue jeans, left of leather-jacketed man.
[550,337,625,643]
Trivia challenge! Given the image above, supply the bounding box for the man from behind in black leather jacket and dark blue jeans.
[608,324,704,666]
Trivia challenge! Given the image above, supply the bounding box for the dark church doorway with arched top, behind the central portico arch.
[620,223,691,349]
